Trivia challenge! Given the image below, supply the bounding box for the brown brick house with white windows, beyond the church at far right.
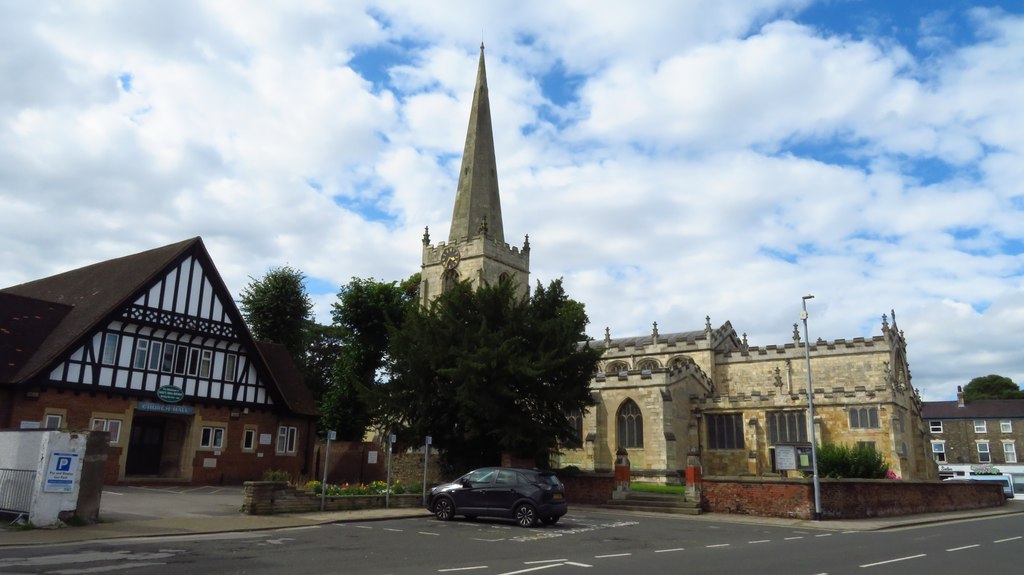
[922,388,1024,493]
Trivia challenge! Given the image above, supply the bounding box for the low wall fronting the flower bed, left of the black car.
[242,481,423,515]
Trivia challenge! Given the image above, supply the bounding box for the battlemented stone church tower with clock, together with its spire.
[420,43,529,305]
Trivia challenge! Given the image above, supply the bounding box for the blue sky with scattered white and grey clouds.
[0,0,1024,400]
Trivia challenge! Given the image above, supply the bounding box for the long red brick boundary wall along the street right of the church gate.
[700,477,1007,519]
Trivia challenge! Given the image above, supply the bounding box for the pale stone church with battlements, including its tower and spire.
[420,44,937,483]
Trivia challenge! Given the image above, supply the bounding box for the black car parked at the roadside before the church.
[427,468,568,527]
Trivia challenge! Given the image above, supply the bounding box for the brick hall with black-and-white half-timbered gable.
[0,237,316,484]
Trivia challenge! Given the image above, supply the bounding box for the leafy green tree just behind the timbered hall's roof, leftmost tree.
[241,266,313,362]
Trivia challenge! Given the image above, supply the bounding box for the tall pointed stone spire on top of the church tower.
[449,42,505,244]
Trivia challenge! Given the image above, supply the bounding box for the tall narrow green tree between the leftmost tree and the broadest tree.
[319,274,420,441]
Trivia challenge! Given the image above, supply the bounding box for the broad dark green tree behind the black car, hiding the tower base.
[381,280,601,470]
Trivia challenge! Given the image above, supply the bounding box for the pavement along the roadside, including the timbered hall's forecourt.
[0,486,1024,547]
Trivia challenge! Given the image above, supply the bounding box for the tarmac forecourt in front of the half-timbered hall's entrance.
[99,485,243,521]
